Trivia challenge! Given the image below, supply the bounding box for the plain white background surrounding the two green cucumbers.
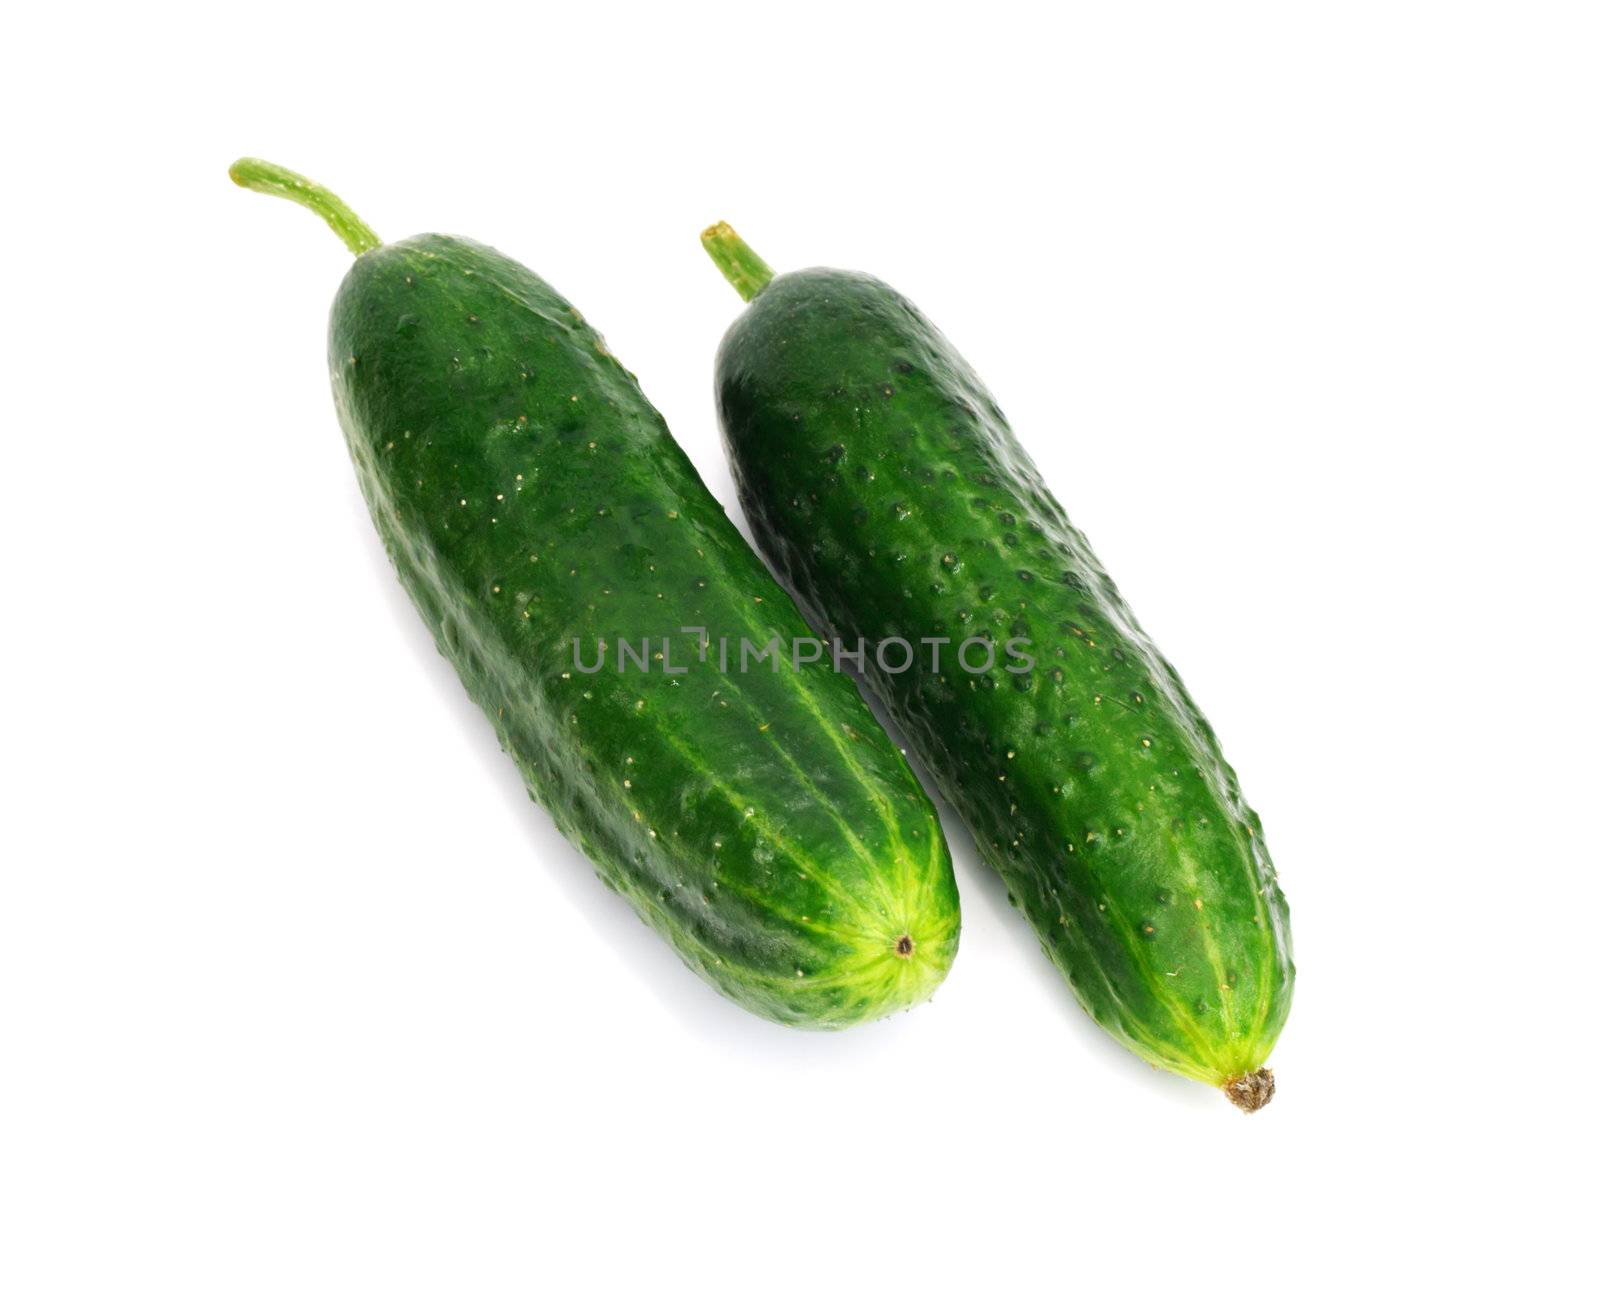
[0,0,1600,1300]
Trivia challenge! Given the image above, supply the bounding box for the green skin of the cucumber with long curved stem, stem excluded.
[328,235,960,1028]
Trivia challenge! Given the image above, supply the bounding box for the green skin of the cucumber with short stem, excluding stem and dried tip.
[717,269,1294,1085]
